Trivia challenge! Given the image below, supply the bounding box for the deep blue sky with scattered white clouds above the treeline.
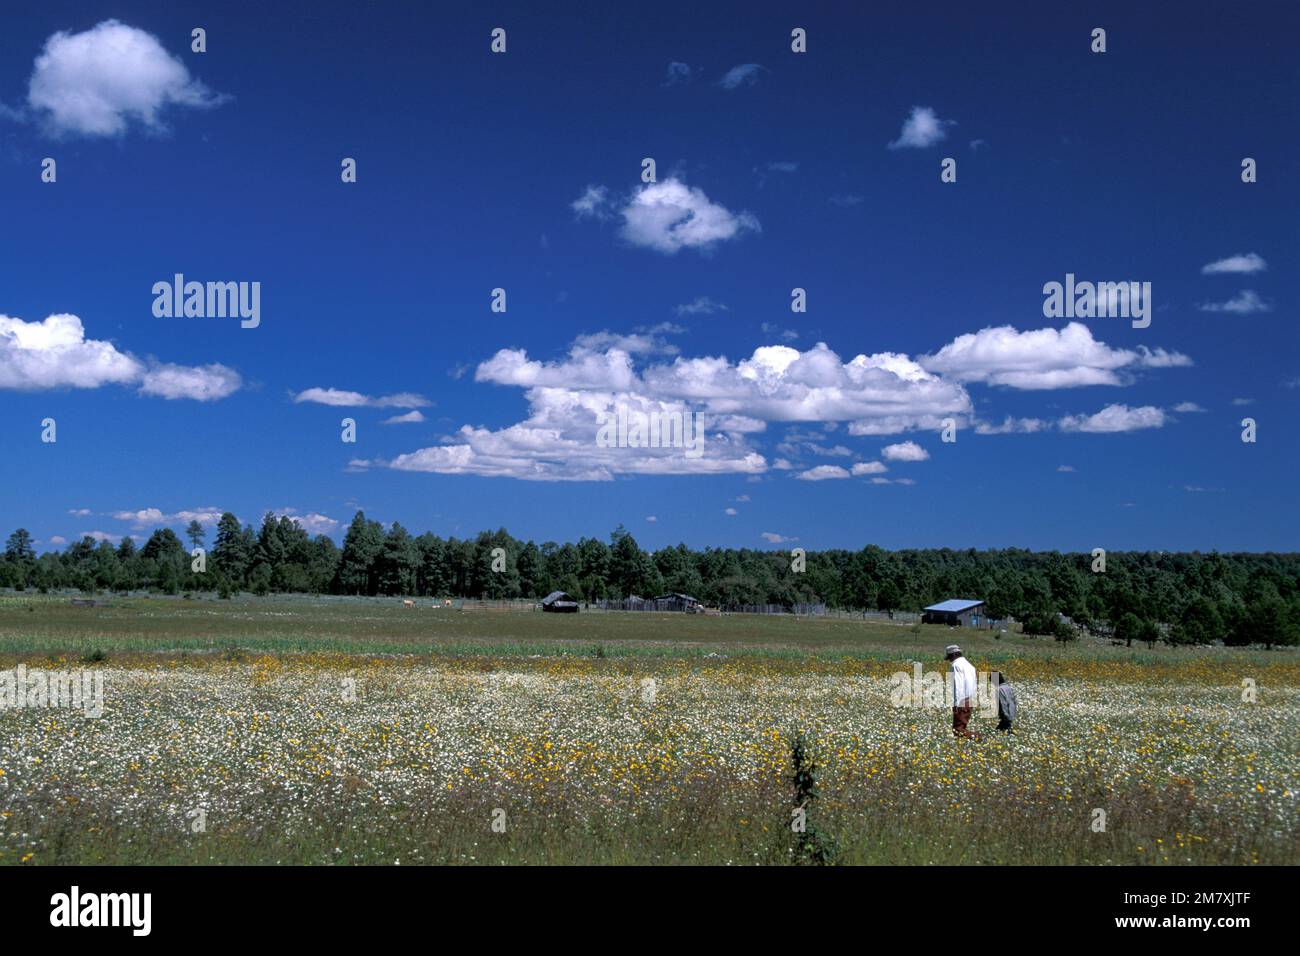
[0,3,1300,550]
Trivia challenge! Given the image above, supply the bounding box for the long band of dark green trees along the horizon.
[0,511,1300,646]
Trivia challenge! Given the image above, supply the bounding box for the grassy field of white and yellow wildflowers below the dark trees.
[0,596,1300,865]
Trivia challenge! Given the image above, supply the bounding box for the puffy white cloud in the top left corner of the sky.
[27,20,228,137]
